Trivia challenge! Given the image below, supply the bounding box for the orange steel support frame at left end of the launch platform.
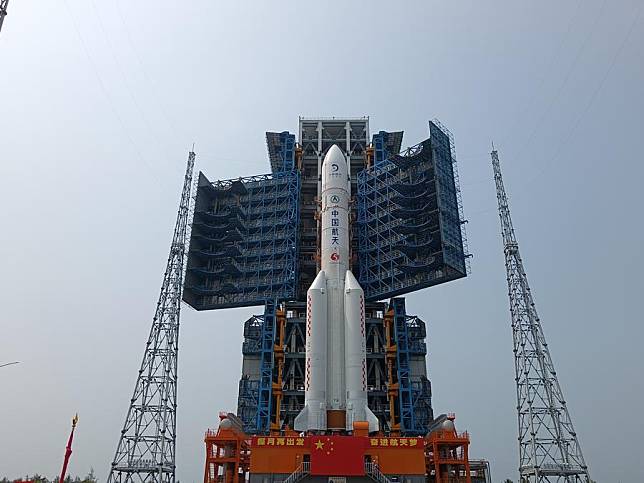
[203,413,250,483]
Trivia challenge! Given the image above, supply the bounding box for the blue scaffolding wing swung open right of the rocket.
[357,124,467,300]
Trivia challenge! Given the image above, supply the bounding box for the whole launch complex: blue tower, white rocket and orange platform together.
[183,117,489,483]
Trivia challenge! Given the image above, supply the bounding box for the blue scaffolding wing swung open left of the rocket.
[183,170,300,310]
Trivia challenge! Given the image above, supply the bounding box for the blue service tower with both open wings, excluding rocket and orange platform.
[183,117,468,436]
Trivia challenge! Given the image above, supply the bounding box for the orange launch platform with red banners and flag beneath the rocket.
[204,413,489,483]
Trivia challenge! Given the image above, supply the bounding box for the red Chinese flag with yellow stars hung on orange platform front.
[310,436,365,476]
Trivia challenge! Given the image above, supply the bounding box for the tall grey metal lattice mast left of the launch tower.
[108,152,195,483]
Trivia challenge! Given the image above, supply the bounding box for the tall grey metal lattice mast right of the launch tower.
[491,150,590,483]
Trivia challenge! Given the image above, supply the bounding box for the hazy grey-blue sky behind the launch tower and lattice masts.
[0,0,644,483]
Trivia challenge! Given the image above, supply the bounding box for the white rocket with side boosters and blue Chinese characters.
[294,145,378,432]
